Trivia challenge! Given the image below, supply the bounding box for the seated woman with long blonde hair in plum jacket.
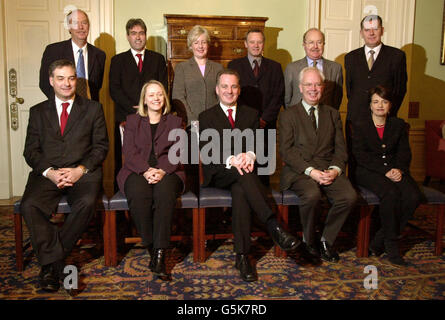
[117,80,185,277]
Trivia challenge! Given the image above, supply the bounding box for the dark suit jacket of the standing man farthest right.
[345,44,408,122]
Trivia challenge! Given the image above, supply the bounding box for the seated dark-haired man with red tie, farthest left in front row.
[20,60,108,291]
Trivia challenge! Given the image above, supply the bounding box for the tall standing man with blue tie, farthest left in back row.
[39,10,105,101]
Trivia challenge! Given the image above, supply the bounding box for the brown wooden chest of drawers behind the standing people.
[164,14,268,88]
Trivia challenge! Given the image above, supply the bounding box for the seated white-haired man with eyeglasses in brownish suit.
[279,67,357,262]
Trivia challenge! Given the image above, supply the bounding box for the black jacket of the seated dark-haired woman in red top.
[352,116,411,175]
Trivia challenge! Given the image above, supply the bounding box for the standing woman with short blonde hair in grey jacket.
[172,25,223,126]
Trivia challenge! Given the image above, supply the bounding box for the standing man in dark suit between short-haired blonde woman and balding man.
[228,29,284,185]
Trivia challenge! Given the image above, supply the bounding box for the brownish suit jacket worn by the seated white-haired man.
[278,102,348,190]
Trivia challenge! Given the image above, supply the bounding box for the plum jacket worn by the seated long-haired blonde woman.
[117,114,185,192]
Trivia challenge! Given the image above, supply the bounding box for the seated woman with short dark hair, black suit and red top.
[352,86,421,265]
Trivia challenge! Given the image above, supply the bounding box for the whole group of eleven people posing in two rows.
[21,10,420,291]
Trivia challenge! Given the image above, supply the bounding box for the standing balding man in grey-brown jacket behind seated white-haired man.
[284,28,343,110]
